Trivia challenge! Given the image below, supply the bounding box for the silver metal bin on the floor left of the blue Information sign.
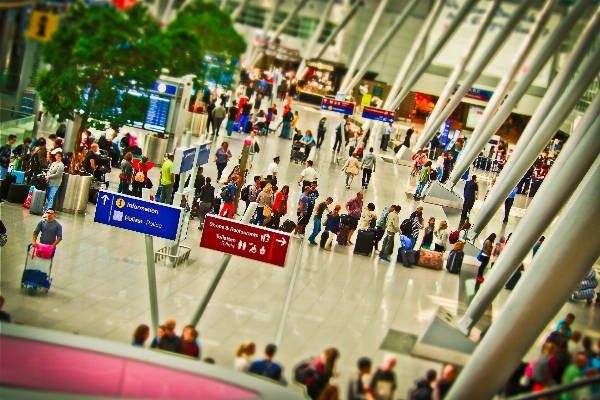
[54,172,92,214]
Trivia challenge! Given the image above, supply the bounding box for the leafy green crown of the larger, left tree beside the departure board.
[36,2,170,131]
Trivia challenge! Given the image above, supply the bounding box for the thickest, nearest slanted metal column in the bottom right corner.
[446,159,600,400]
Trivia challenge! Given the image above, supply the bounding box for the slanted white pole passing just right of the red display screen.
[417,0,502,149]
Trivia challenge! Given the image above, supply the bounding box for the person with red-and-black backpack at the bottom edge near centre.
[294,347,340,400]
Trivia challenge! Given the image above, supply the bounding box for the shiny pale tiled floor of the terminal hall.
[0,100,600,396]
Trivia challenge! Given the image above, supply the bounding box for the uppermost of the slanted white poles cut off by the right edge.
[474,8,600,193]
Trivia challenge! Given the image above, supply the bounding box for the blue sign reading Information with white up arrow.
[94,190,182,240]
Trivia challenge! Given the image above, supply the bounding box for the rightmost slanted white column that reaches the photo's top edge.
[450,0,591,185]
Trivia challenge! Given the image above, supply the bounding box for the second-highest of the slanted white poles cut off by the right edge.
[473,34,600,236]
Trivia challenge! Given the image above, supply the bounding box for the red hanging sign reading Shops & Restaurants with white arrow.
[200,215,291,267]
